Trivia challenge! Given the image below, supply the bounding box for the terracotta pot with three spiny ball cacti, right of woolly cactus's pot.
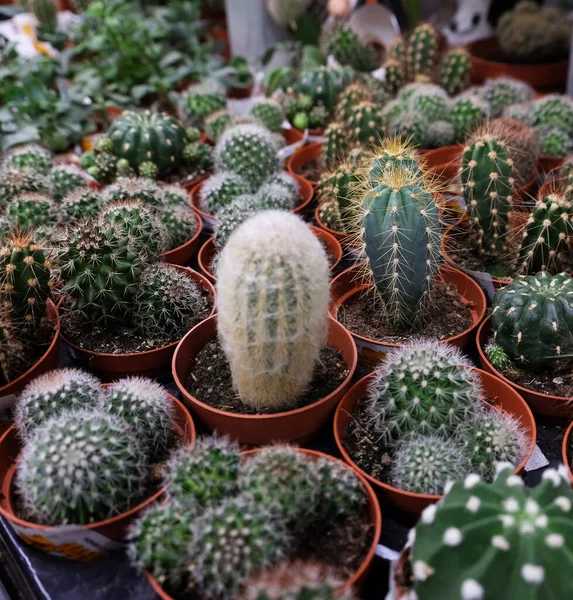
[334,368,537,513]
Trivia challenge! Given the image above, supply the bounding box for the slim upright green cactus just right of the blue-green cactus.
[461,129,514,255]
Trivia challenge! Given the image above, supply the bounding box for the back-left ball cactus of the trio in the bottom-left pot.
[14,368,102,440]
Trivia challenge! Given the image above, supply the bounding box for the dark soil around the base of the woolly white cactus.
[186,340,348,415]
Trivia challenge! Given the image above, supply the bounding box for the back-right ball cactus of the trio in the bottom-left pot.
[102,377,176,464]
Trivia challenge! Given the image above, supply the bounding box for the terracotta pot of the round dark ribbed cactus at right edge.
[476,317,573,419]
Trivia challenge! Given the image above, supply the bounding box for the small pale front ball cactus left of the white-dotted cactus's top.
[390,435,470,494]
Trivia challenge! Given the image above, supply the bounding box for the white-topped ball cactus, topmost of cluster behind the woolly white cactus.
[214,125,279,192]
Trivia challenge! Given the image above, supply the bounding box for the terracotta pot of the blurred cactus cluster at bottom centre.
[146,448,382,600]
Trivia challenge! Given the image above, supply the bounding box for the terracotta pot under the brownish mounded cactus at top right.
[468,36,569,92]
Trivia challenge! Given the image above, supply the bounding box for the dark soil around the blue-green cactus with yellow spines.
[338,282,473,344]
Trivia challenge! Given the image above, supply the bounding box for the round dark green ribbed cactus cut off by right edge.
[491,271,573,371]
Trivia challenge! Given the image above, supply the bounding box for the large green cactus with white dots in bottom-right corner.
[404,467,573,600]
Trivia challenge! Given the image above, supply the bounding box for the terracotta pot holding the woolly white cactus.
[172,316,357,446]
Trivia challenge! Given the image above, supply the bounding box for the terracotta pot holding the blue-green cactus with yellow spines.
[330,265,486,368]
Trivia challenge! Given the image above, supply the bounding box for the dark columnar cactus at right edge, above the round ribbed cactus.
[517,191,573,275]
